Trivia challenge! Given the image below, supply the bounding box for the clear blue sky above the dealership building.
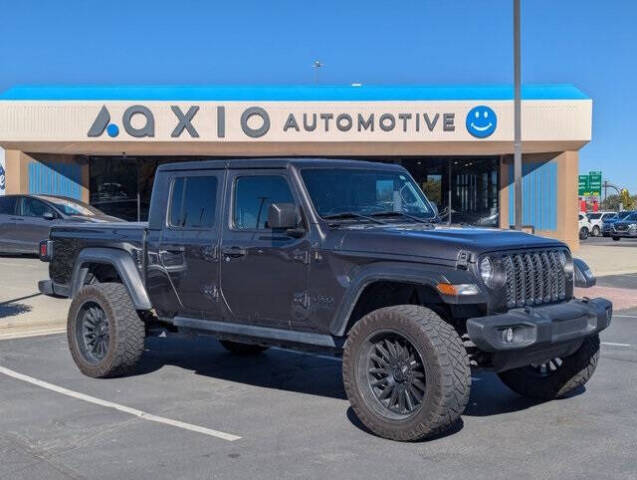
[0,0,637,193]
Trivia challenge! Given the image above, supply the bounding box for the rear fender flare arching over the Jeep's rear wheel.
[70,248,152,310]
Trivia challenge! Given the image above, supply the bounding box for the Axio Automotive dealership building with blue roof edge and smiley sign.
[0,84,592,248]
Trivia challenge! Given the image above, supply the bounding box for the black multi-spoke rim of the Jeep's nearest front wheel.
[365,331,427,418]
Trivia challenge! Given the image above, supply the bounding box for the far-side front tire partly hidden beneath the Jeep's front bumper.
[498,335,599,400]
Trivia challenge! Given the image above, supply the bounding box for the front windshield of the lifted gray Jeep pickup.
[301,168,435,220]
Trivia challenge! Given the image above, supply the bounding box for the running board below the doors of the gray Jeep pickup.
[172,317,337,348]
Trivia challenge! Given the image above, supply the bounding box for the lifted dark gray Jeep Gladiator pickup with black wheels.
[40,159,612,440]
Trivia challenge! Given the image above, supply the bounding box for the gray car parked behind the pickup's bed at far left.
[0,195,123,254]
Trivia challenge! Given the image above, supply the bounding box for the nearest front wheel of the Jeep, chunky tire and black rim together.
[343,305,471,441]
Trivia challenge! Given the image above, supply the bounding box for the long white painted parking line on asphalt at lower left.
[0,366,241,442]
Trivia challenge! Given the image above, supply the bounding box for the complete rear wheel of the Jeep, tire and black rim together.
[67,283,146,378]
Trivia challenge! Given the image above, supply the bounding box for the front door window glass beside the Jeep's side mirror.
[232,175,294,230]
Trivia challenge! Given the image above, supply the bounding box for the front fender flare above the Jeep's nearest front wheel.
[329,262,486,337]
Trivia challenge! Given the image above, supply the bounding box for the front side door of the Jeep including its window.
[220,169,309,328]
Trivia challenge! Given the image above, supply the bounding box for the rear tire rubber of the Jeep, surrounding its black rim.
[67,283,146,378]
